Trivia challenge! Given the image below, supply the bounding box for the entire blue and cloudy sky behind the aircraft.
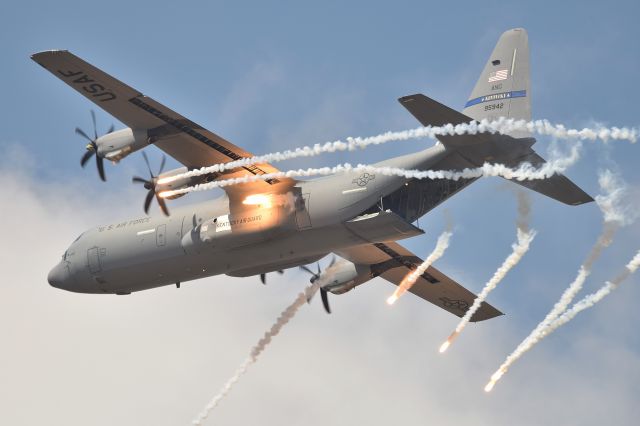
[0,0,640,425]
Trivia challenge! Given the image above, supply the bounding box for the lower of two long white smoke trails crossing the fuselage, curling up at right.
[159,144,581,197]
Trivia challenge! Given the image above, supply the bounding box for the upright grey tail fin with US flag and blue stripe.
[462,28,531,138]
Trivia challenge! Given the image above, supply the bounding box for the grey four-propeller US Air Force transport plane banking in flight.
[37,29,593,321]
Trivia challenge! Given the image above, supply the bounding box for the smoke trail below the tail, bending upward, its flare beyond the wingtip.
[440,191,536,353]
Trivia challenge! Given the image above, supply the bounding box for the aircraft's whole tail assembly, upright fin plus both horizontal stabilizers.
[399,28,593,205]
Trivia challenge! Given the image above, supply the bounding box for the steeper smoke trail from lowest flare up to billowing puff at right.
[485,170,635,392]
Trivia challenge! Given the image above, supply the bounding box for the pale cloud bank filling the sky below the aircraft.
[0,156,640,425]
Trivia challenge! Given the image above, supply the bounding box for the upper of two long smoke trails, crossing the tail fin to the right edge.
[159,117,640,184]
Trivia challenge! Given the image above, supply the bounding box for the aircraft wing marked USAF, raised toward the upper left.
[31,50,294,198]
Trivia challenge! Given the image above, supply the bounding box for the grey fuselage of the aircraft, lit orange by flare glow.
[49,144,448,294]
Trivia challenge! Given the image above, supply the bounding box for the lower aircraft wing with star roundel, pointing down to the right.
[336,242,502,322]
